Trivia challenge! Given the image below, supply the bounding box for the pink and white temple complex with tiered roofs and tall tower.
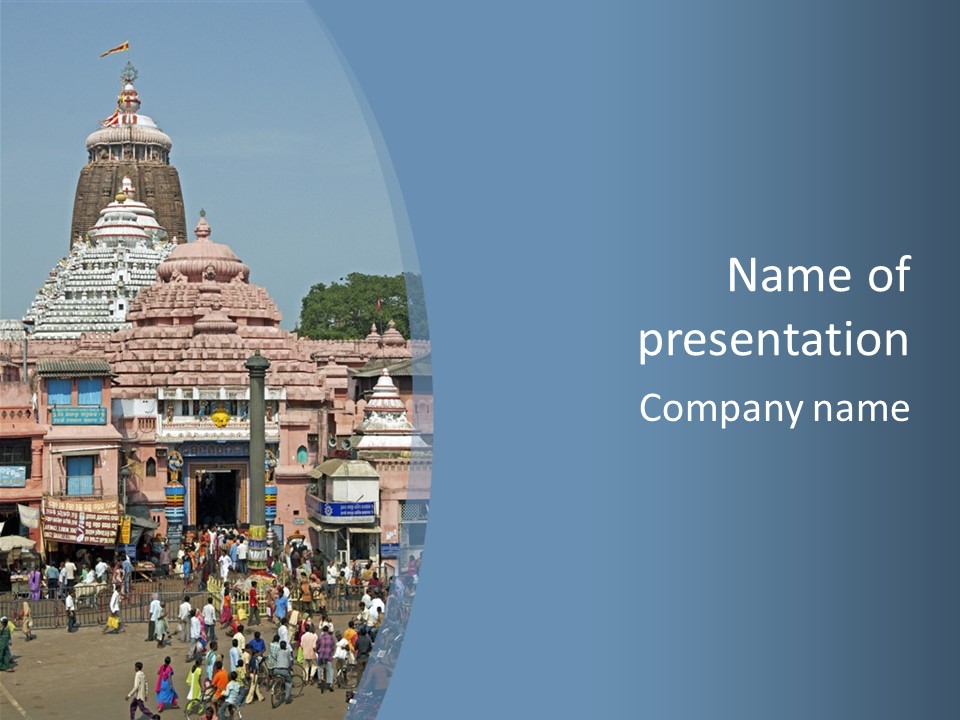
[0,64,433,564]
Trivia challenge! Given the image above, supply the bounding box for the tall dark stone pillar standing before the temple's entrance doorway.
[244,350,270,574]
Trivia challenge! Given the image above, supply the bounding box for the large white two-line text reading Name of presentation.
[640,255,911,365]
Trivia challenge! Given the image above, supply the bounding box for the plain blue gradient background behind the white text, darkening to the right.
[314,0,960,720]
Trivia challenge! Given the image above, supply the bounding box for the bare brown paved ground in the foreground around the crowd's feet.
[0,616,347,720]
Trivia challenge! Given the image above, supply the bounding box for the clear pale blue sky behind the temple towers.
[0,0,403,328]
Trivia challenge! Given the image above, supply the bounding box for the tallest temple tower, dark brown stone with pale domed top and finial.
[68,63,187,247]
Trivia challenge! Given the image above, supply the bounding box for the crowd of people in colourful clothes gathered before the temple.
[0,528,419,718]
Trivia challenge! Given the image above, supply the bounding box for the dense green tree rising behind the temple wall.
[297,273,410,340]
